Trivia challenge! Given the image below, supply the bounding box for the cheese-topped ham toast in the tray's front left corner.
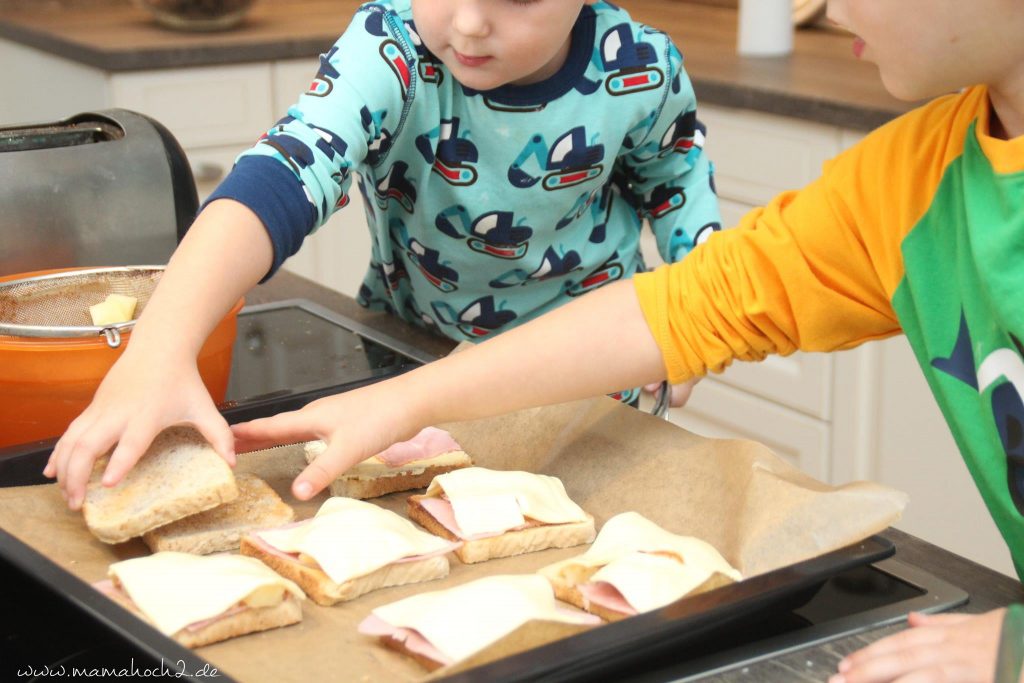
[95,552,305,647]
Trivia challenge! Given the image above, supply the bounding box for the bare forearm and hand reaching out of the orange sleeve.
[233,282,665,500]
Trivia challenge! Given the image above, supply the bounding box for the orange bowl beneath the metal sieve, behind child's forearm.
[0,273,245,446]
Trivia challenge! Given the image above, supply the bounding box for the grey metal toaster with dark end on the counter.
[0,109,199,275]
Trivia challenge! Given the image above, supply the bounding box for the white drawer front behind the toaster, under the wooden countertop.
[111,63,275,148]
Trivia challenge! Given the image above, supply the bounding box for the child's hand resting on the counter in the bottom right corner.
[828,609,1006,683]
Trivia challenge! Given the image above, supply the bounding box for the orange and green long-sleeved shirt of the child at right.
[635,87,1024,577]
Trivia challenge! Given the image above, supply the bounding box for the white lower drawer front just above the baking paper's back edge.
[644,379,830,481]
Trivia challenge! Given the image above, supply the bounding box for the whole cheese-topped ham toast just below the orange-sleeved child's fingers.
[242,498,458,605]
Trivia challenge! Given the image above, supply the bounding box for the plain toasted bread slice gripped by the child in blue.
[82,427,239,544]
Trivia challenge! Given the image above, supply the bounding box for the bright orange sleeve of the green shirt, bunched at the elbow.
[634,89,987,382]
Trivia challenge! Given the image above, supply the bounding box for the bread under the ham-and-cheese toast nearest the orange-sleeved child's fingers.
[240,536,449,606]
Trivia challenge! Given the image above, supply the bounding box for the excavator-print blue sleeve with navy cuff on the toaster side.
[207,5,416,276]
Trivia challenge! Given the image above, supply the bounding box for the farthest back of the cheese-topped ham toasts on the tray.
[408,467,594,564]
